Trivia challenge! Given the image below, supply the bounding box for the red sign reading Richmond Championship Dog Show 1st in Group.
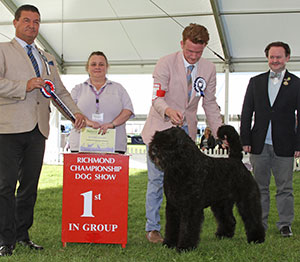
[61,153,129,248]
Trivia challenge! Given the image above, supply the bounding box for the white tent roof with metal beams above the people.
[0,0,300,74]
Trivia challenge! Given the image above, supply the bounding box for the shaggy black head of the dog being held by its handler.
[149,127,195,170]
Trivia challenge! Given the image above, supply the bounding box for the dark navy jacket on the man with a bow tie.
[241,70,300,157]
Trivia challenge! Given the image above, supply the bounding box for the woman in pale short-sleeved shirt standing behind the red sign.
[69,51,134,153]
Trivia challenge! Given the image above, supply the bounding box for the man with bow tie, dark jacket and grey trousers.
[241,42,300,237]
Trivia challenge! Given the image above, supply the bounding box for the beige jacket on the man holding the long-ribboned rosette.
[0,39,80,138]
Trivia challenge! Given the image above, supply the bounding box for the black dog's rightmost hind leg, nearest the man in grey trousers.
[237,192,265,243]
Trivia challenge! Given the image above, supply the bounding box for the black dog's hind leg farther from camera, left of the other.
[211,200,236,238]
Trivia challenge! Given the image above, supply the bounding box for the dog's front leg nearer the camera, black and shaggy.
[176,206,204,252]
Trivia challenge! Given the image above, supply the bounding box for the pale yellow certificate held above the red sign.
[79,127,116,153]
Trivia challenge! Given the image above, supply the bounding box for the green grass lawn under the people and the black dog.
[0,166,300,262]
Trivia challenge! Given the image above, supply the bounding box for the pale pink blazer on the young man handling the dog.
[142,51,222,144]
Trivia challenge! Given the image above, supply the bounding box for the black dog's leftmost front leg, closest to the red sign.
[163,201,179,248]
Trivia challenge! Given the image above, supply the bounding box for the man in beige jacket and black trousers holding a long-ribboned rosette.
[0,5,86,256]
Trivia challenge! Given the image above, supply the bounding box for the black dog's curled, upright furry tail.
[217,125,243,160]
